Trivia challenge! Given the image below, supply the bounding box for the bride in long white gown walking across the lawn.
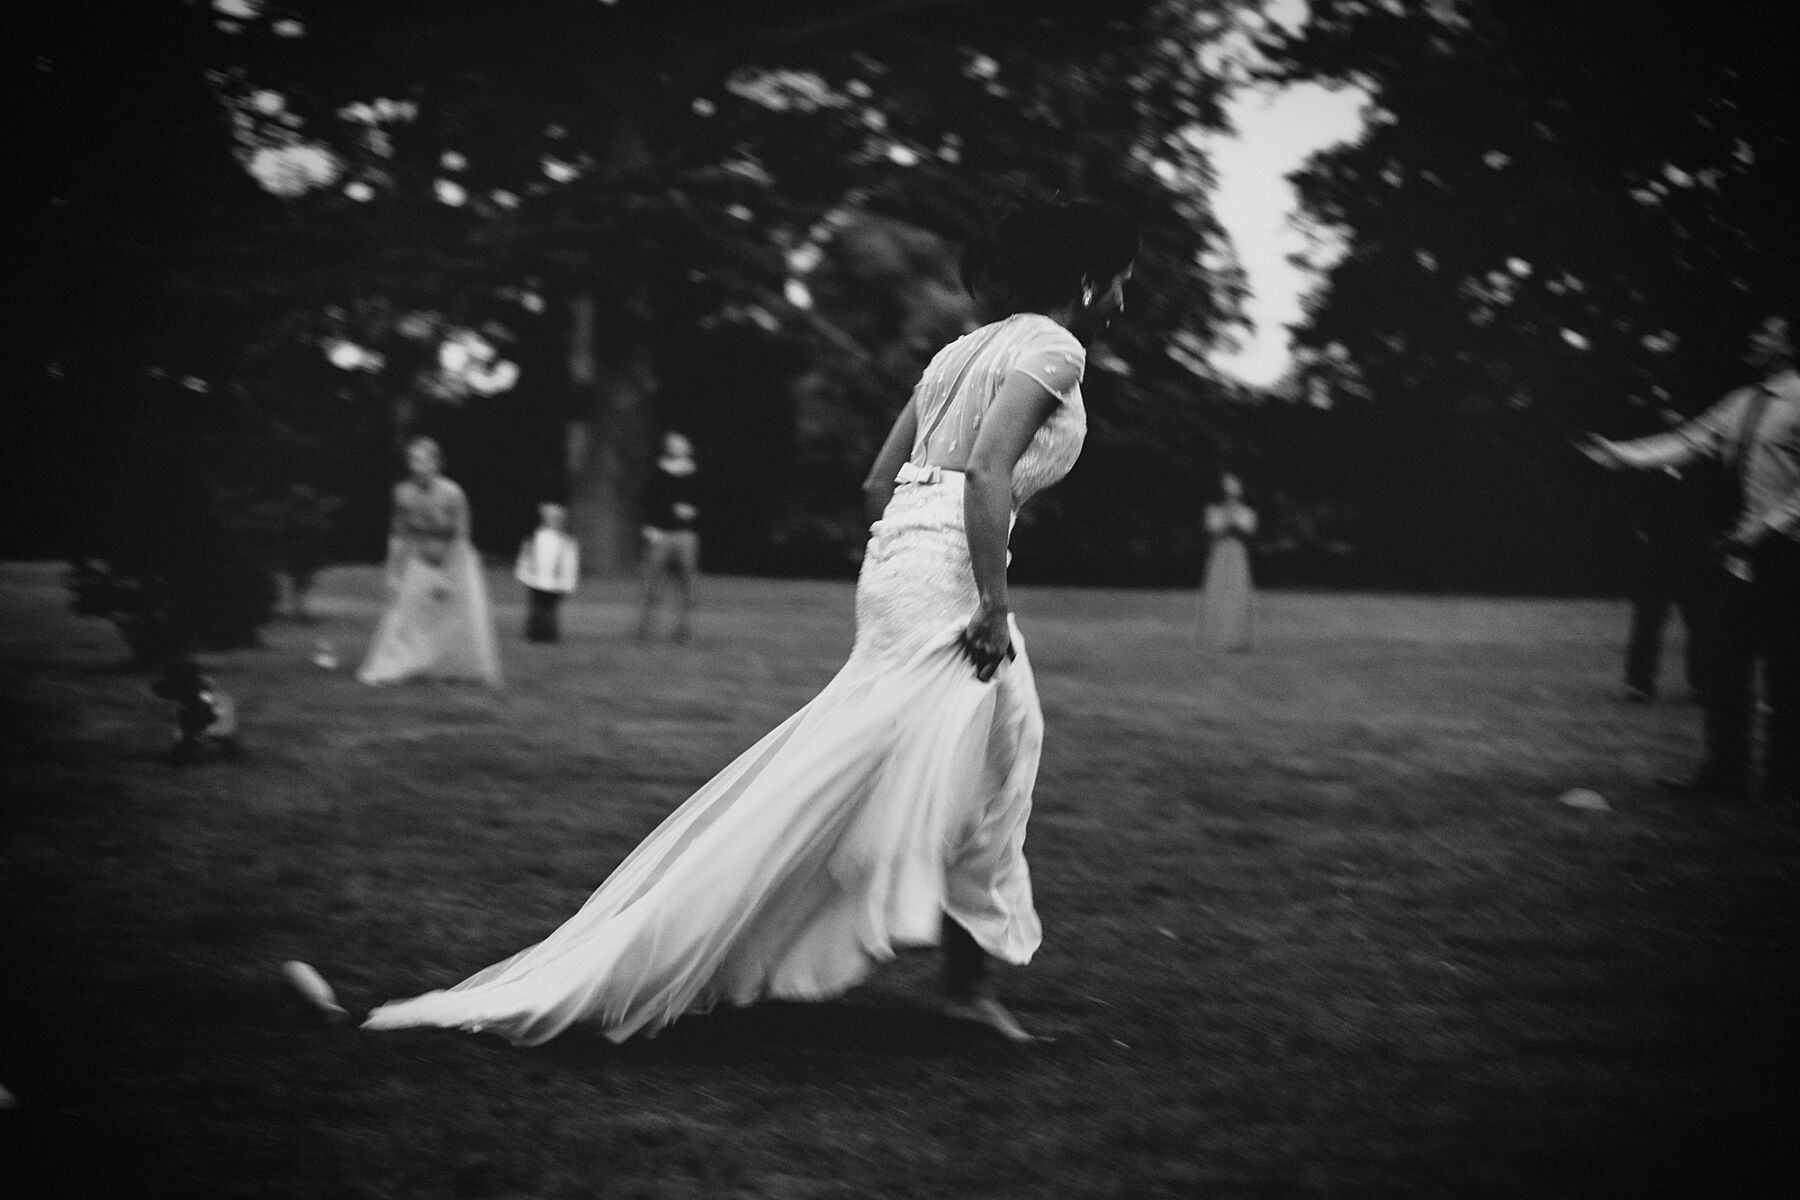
[364,201,1138,1045]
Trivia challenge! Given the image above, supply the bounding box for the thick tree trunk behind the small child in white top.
[567,293,655,576]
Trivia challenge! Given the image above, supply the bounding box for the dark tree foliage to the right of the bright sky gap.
[1278,0,1800,585]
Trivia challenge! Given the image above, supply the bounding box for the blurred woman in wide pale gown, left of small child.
[356,437,500,684]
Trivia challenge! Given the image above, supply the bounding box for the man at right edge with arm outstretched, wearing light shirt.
[1577,311,1800,802]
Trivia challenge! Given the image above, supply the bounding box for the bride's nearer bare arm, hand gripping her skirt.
[963,371,1058,680]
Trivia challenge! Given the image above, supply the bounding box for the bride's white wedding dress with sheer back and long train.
[364,313,1087,1045]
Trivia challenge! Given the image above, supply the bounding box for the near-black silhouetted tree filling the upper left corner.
[15,5,286,651]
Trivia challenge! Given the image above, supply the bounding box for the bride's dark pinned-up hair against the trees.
[961,198,1139,315]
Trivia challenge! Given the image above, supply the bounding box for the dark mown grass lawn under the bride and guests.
[0,565,1800,1200]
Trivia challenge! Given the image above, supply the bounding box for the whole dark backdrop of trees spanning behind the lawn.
[21,0,1771,587]
